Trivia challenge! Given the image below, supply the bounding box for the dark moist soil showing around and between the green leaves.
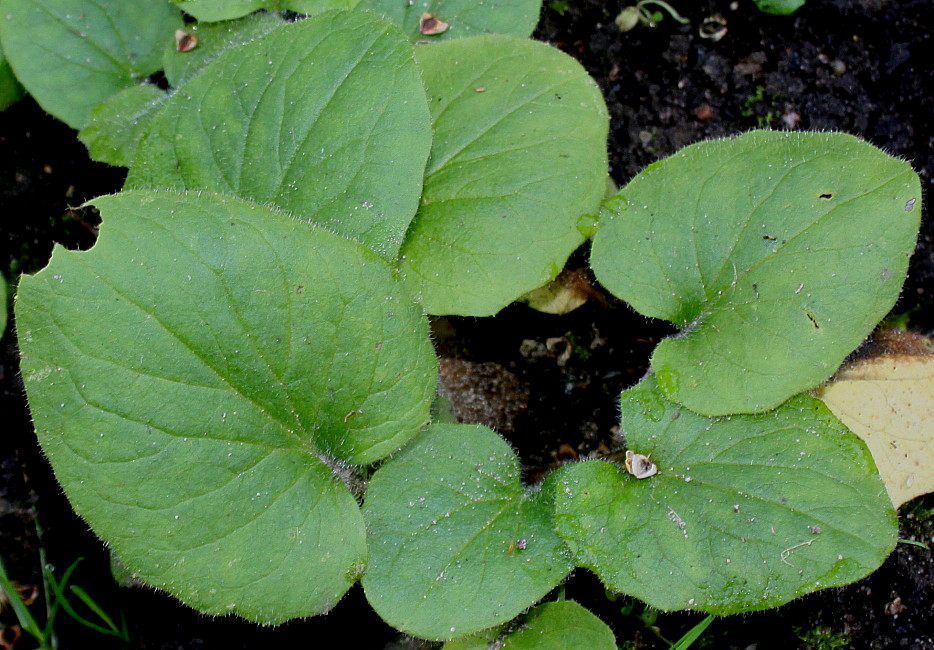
[0,0,934,650]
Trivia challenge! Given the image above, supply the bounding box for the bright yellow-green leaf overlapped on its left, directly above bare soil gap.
[400,36,608,316]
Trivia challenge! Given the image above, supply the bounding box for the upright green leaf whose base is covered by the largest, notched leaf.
[127,12,431,258]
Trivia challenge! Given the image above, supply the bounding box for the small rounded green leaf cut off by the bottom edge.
[500,600,616,650]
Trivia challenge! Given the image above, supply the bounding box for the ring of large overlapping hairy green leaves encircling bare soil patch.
[7,0,921,647]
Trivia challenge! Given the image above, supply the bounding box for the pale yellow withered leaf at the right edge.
[817,336,934,508]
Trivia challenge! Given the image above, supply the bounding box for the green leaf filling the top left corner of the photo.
[0,0,182,129]
